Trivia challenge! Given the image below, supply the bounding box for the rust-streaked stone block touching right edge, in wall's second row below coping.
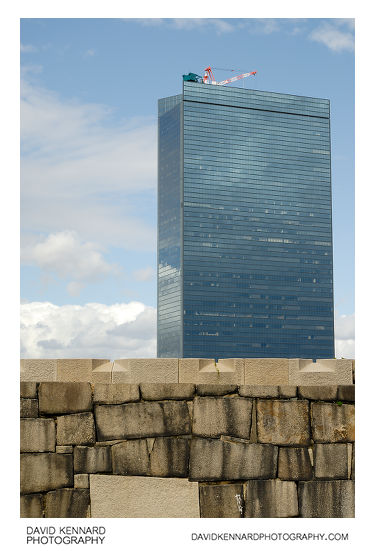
[311,402,355,443]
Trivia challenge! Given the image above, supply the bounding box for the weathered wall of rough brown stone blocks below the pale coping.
[21,382,354,518]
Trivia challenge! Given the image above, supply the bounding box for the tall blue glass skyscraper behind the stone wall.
[158,82,334,358]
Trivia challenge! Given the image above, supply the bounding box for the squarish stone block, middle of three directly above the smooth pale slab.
[112,439,150,476]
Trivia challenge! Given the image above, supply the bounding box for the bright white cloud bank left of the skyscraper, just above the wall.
[21,302,156,360]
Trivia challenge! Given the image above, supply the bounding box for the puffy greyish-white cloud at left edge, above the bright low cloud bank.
[21,231,118,296]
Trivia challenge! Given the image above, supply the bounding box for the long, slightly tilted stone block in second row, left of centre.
[95,401,191,441]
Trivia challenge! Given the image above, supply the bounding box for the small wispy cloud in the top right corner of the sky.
[309,19,354,52]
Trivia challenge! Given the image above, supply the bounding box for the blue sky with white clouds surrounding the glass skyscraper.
[21,19,354,358]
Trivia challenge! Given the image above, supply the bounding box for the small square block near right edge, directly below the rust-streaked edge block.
[314,444,350,479]
